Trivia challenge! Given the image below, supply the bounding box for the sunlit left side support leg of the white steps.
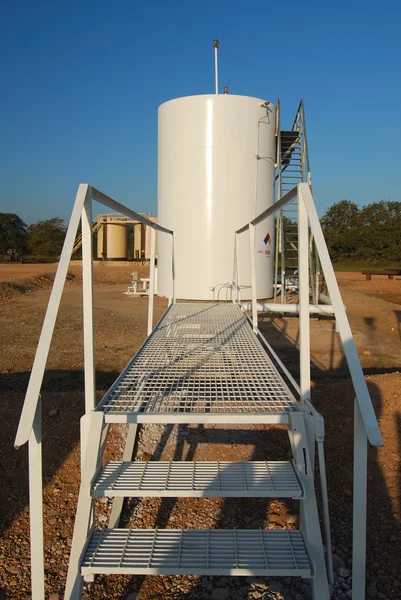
[64,412,104,600]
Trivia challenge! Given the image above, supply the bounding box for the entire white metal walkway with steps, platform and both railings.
[15,183,382,600]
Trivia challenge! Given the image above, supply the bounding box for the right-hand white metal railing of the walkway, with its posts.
[233,183,383,600]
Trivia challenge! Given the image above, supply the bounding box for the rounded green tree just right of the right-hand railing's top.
[320,200,360,262]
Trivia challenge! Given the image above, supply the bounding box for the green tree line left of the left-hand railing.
[0,213,66,261]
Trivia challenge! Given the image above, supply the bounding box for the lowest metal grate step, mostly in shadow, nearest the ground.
[81,529,313,577]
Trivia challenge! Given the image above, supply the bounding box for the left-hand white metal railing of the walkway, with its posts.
[14,183,175,600]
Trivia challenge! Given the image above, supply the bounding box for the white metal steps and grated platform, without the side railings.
[65,303,329,600]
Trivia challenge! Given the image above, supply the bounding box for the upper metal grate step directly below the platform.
[93,461,303,498]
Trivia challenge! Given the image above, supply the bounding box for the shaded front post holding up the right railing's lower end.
[352,398,367,600]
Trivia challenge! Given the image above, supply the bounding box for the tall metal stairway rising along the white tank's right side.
[274,100,321,304]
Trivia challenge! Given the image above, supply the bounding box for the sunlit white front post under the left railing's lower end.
[28,395,45,600]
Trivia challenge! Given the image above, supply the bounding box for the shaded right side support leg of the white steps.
[288,412,330,600]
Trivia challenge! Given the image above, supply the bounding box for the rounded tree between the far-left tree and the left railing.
[27,217,66,257]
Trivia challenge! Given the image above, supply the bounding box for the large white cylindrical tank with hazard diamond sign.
[158,94,275,300]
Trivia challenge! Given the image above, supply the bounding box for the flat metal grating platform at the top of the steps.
[97,303,299,423]
